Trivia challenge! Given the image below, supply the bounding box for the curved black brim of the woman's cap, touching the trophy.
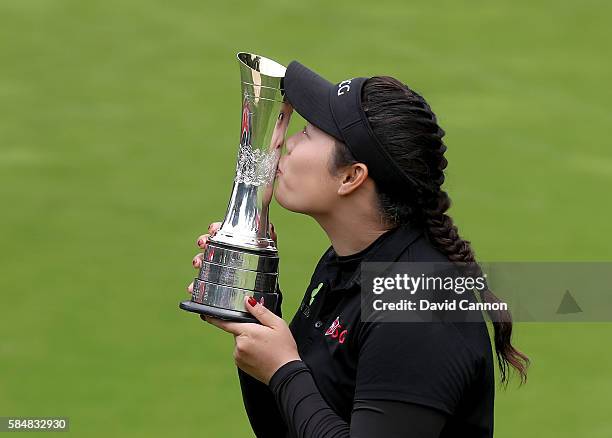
[283,61,343,141]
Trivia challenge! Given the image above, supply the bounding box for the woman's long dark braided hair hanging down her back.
[331,76,529,385]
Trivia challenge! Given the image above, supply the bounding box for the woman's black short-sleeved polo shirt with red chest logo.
[284,225,495,438]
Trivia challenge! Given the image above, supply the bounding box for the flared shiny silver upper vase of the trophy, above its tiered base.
[210,52,290,253]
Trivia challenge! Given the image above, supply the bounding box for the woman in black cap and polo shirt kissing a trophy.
[188,61,528,438]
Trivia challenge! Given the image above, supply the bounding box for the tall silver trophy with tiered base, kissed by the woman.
[179,52,291,322]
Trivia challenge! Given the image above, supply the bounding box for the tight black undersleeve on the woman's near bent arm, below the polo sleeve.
[270,360,446,438]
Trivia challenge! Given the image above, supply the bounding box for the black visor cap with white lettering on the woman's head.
[283,61,415,197]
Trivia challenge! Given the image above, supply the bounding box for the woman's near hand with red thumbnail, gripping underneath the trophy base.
[201,297,300,385]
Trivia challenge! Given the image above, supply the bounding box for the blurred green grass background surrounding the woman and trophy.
[0,0,612,438]
